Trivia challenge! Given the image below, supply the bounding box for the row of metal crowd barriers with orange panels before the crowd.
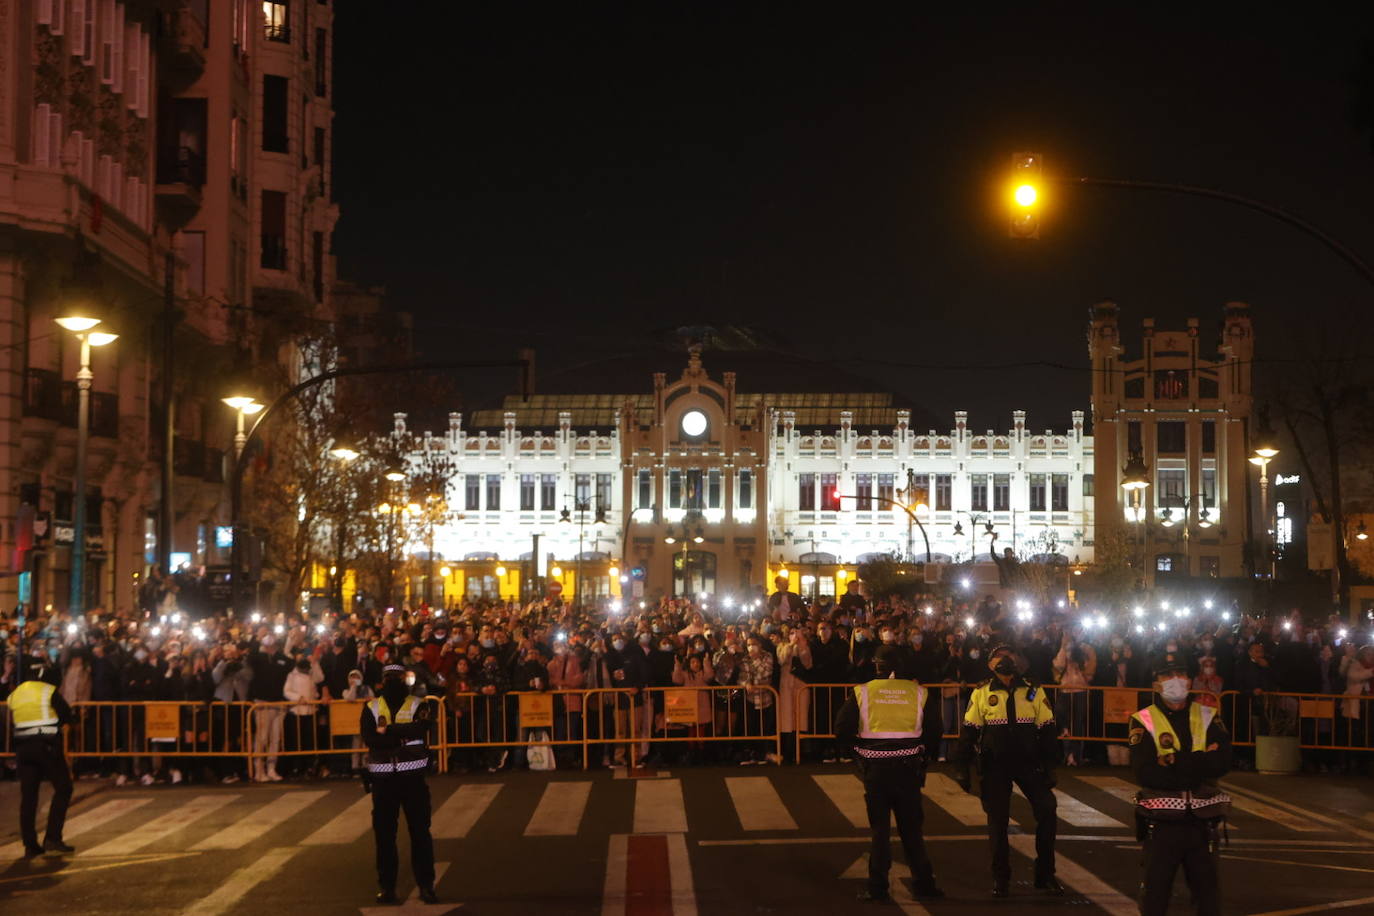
[0,684,1374,772]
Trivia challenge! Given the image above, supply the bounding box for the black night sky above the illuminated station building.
[334,3,1374,428]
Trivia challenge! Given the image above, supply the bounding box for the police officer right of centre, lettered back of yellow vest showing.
[835,645,944,901]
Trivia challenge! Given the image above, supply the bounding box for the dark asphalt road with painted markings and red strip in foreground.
[0,765,1374,916]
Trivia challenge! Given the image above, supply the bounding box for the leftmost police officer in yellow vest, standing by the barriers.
[7,656,76,858]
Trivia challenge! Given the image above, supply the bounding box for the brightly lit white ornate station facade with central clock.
[397,350,1095,600]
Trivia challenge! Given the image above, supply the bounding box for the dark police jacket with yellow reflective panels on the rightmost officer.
[1128,700,1231,820]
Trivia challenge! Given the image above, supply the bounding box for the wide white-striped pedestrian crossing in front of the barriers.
[0,768,1341,862]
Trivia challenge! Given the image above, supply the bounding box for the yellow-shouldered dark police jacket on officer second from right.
[955,677,1059,769]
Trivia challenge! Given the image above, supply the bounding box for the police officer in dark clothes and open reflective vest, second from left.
[360,665,438,904]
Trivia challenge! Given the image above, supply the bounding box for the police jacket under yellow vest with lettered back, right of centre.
[835,677,944,759]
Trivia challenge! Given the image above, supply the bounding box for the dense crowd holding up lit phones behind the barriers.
[0,581,1374,784]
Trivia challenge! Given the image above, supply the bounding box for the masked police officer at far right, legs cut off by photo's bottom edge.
[1128,652,1231,916]
